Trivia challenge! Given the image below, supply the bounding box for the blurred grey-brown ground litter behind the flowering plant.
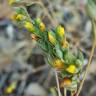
[0,0,96,96]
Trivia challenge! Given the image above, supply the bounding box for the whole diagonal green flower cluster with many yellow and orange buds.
[11,5,83,90]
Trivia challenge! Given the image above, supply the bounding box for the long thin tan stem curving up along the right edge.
[76,41,96,96]
